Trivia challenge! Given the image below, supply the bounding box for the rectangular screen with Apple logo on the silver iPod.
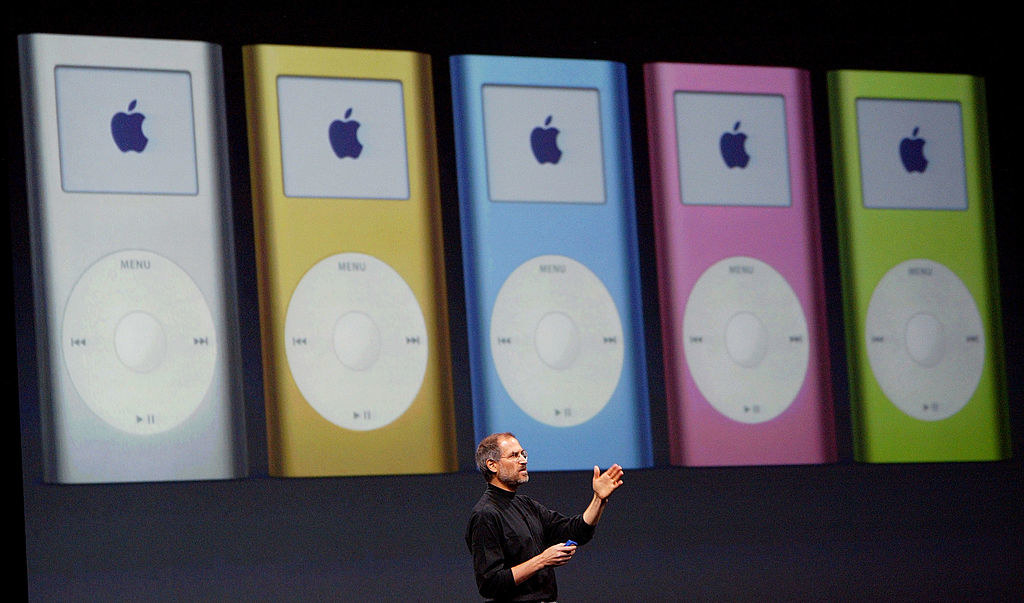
[54,67,199,195]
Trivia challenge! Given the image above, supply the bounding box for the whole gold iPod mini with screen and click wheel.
[243,45,457,477]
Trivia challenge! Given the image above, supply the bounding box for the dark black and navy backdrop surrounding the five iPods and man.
[0,2,1024,601]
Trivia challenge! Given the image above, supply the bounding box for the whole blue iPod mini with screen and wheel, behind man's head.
[451,55,651,470]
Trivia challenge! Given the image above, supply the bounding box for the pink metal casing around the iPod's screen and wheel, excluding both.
[644,62,836,466]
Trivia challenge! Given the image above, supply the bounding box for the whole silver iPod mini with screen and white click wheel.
[18,34,246,483]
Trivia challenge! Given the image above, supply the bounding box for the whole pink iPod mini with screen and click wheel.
[644,62,836,466]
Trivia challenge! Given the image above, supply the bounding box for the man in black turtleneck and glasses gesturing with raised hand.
[466,433,623,601]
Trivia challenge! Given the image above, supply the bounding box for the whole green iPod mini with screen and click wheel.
[828,71,1010,463]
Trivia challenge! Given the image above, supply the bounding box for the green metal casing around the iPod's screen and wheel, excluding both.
[828,71,1010,463]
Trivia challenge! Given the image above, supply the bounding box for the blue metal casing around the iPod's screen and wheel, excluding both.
[450,55,652,470]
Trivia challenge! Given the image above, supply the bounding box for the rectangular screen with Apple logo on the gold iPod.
[278,76,410,200]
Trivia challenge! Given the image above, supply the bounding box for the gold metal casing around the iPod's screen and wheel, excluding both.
[243,45,457,476]
